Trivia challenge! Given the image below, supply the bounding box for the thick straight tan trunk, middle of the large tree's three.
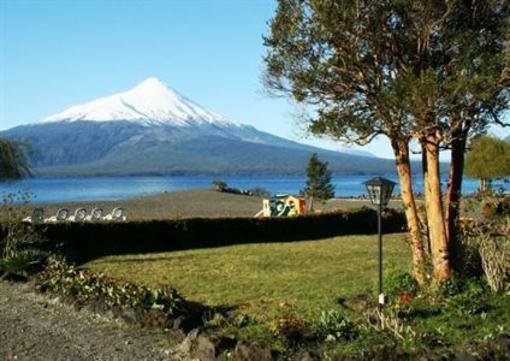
[422,136,451,282]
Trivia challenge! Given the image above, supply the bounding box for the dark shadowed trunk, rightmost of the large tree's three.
[445,129,466,272]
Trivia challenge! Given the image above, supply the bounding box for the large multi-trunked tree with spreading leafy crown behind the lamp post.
[265,0,510,282]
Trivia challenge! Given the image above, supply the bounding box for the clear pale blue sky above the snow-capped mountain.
[0,0,508,157]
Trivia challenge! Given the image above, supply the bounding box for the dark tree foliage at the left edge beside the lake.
[0,139,30,182]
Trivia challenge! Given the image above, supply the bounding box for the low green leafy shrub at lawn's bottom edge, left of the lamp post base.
[313,311,358,341]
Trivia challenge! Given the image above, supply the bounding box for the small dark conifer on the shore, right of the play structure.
[303,153,335,210]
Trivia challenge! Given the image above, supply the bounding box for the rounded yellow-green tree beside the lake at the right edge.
[466,136,510,192]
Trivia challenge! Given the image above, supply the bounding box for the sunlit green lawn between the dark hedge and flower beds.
[86,234,410,319]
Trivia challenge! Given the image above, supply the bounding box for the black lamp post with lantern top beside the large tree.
[363,177,396,311]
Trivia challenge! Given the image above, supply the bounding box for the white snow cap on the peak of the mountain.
[42,78,239,126]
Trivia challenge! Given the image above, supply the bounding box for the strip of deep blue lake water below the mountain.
[0,176,510,203]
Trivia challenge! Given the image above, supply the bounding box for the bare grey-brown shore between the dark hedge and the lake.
[35,189,400,220]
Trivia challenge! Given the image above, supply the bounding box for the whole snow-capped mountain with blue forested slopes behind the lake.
[0,78,394,176]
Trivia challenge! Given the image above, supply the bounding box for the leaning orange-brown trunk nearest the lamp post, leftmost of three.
[391,140,426,285]
